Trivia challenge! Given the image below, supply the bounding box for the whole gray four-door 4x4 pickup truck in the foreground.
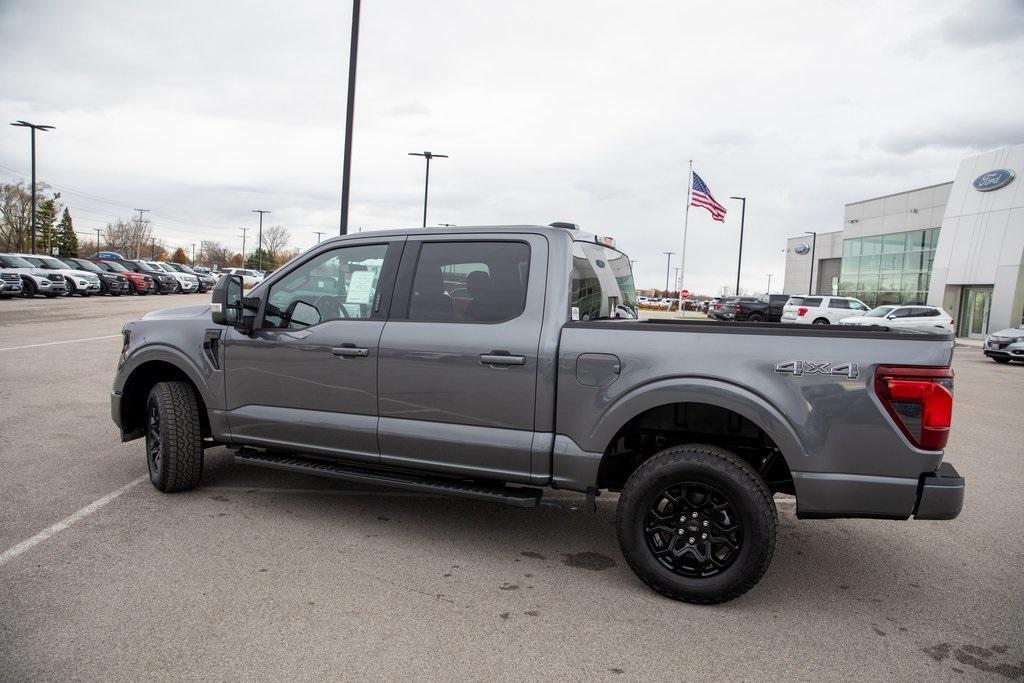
[112,226,964,603]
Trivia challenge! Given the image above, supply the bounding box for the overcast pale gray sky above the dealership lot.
[0,0,1024,293]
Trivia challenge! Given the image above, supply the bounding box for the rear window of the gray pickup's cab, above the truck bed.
[569,242,637,321]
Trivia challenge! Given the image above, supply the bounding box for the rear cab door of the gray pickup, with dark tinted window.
[378,233,548,482]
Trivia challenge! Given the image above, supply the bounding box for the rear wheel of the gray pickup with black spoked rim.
[615,443,777,604]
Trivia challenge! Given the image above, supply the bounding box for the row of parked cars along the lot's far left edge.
[0,254,217,298]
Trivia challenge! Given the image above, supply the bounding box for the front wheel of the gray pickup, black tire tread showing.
[145,382,203,494]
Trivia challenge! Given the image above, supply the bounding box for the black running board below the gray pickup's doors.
[234,449,543,508]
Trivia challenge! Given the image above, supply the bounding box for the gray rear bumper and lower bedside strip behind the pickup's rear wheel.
[793,463,966,519]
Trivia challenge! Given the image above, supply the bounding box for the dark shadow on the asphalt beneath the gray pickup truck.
[195,450,946,618]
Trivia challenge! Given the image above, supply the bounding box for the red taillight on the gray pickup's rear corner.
[874,366,953,451]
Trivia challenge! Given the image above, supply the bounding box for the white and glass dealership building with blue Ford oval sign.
[783,144,1024,338]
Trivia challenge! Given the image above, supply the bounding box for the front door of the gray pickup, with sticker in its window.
[224,239,403,463]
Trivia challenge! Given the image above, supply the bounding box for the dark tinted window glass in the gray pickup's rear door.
[409,240,529,323]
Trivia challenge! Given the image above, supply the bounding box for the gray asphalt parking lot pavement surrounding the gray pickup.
[0,295,1024,681]
